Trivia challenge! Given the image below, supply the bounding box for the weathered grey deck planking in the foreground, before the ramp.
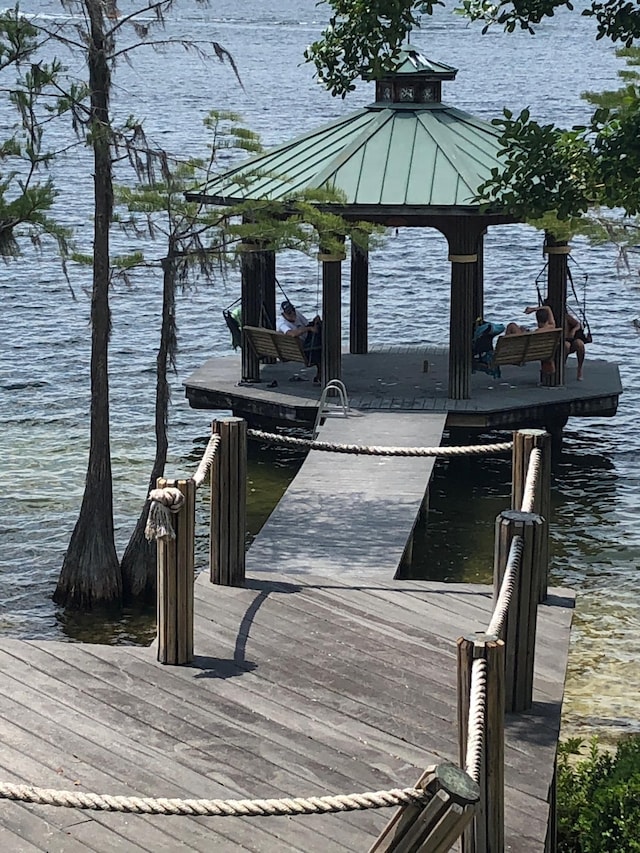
[0,573,572,853]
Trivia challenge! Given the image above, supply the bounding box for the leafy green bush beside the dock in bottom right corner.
[558,735,640,853]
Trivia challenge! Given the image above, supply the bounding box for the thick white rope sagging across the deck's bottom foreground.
[0,782,431,817]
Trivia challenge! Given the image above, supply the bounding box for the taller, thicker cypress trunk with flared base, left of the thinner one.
[53,0,122,610]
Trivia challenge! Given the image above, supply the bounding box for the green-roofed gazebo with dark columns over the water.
[187,45,570,400]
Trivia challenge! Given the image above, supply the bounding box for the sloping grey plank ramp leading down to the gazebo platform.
[247,412,446,578]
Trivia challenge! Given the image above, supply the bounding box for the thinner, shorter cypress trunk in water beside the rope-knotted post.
[120,255,177,604]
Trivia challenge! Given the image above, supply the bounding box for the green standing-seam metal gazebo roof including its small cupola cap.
[188,49,501,213]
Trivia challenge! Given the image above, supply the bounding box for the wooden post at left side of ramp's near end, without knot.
[209,417,247,586]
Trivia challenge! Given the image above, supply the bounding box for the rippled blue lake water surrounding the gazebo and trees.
[0,0,640,736]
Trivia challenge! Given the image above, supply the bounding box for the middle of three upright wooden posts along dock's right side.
[493,510,543,711]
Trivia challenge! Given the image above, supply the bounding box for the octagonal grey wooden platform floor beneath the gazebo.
[184,346,622,430]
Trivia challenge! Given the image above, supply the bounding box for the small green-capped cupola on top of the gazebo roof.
[375,45,458,109]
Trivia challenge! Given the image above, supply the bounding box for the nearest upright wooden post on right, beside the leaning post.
[458,634,505,853]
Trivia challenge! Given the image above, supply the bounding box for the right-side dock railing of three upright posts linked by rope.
[458,430,550,853]
